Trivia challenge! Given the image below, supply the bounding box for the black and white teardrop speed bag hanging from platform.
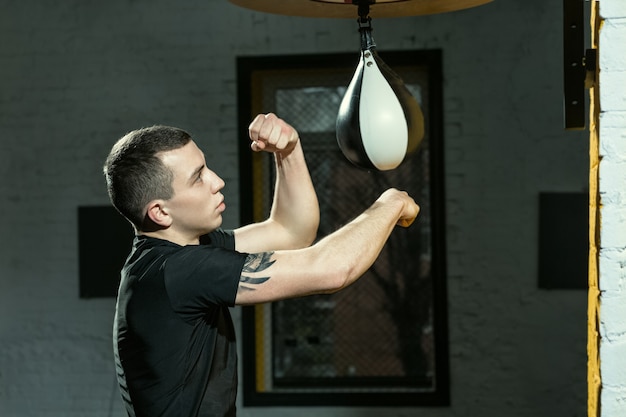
[336,32,424,171]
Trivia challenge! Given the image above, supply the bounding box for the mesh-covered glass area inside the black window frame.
[254,66,434,390]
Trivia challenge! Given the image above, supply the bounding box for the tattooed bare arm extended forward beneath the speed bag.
[235,189,419,305]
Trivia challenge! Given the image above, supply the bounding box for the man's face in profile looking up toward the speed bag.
[159,141,226,239]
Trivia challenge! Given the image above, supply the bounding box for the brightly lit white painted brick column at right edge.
[598,0,626,417]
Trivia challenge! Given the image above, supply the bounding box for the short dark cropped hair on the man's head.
[104,126,191,230]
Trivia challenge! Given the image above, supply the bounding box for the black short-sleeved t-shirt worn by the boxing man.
[113,230,246,417]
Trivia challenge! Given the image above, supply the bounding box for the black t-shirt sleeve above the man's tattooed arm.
[164,244,247,315]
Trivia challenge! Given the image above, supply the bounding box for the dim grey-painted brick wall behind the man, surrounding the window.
[0,0,588,417]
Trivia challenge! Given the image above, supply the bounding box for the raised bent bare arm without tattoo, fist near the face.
[235,113,319,252]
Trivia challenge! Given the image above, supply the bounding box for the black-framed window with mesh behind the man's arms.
[237,50,449,406]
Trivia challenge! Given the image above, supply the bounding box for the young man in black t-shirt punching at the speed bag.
[104,114,419,417]
